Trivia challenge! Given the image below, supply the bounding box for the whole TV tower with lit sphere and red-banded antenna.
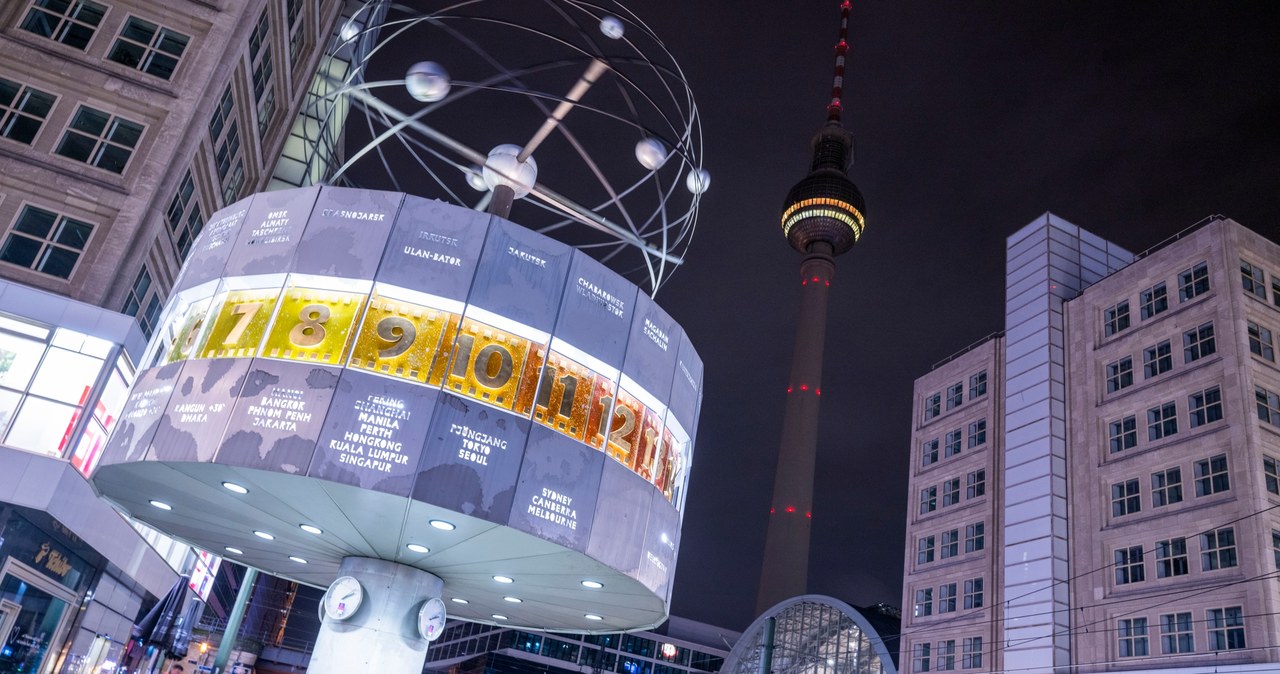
[756,0,867,613]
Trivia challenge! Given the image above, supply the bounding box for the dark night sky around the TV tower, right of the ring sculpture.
[611,0,1280,629]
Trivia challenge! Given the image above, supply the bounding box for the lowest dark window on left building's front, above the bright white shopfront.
[0,206,93,279]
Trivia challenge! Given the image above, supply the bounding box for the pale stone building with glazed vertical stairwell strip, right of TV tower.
[901,215,1280,671]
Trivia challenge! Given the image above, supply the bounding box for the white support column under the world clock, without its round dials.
[307,558,444,674]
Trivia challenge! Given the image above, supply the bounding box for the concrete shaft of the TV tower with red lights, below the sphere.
[756,244,836,614]
